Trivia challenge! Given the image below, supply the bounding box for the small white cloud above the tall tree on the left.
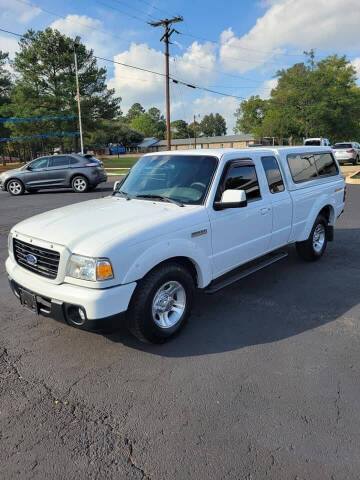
[50,14,113,55]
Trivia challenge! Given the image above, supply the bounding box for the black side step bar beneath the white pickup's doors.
[204,252,288,294]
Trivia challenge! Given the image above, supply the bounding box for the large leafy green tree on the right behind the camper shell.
[235,50,360,143]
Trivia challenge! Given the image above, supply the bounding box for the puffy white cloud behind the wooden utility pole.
[108,42,216,116]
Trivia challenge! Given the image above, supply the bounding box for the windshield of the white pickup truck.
[117,155,217,205]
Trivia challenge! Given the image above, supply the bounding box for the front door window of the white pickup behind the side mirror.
[223,165,261,200]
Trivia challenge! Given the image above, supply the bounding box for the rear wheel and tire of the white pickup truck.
[296,215,328,262]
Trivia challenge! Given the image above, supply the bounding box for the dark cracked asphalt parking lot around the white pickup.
[0,184,360,480]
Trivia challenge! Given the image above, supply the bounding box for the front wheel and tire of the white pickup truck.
[127,263,195,343]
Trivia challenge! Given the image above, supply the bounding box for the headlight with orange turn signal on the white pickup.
[67,255,114,282]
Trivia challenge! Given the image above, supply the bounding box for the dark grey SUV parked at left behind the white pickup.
[0,154,107,195]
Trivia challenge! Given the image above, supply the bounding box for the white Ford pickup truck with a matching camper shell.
[6,147,345,343]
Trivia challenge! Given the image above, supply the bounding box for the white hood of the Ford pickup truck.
[12,196,207,256]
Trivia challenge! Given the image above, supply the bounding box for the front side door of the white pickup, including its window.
[209,159,272,278]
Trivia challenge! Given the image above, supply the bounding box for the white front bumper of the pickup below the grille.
[5,257,136,322]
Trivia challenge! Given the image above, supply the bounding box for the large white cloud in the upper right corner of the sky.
[220,0,360,73]
